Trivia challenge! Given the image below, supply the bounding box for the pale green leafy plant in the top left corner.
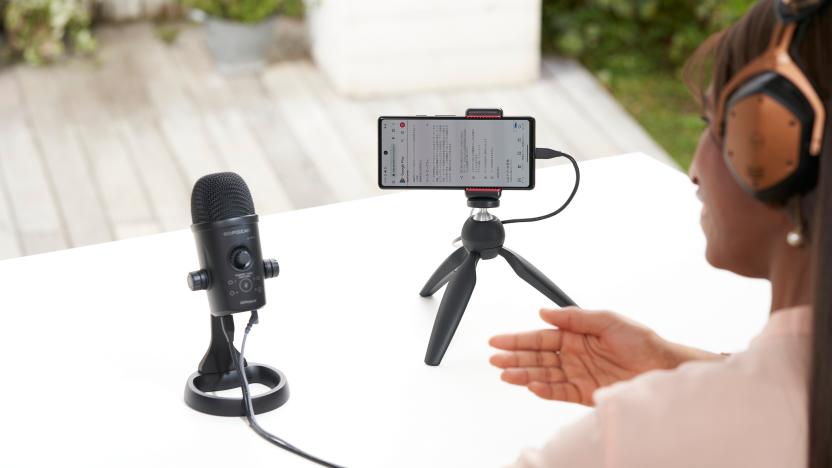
[3,0,96,65]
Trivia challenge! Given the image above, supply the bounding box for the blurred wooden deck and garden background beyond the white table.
[0,0,752,259]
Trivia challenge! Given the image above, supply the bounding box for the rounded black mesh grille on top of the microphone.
[191,172,254,224]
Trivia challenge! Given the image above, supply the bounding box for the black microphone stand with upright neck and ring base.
[185,315,289,416]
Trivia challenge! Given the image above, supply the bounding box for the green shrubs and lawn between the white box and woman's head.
[542,0,755,168]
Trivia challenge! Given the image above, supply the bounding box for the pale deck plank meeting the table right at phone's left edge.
[262,63,376,200]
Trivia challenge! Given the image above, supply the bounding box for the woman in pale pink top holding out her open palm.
[491,0,832,468]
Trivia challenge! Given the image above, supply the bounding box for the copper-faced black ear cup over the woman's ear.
[722,72,818,204]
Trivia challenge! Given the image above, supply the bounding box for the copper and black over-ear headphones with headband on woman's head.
[714,0,832,204]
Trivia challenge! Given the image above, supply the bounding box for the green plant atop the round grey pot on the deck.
[181,0,304,23]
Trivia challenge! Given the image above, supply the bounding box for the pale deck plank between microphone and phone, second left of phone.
[228,75,337,208]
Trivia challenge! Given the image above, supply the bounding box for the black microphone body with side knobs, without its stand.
[187,172,280,317]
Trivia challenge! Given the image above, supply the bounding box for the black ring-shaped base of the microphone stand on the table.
[185,363,289,416]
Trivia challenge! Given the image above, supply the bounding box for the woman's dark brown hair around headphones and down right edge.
[684,0,832,468]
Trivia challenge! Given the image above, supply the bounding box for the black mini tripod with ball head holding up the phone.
[419,189,575,366]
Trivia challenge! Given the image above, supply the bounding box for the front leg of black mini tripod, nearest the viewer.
[425,252,480,366]
